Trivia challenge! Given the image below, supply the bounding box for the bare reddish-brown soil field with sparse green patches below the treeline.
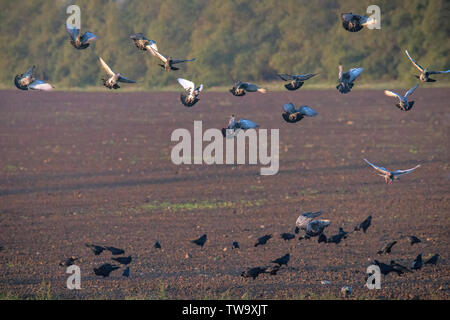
[0,88,450,299]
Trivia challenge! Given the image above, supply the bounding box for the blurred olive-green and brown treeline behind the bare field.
[0,0,450,88]
